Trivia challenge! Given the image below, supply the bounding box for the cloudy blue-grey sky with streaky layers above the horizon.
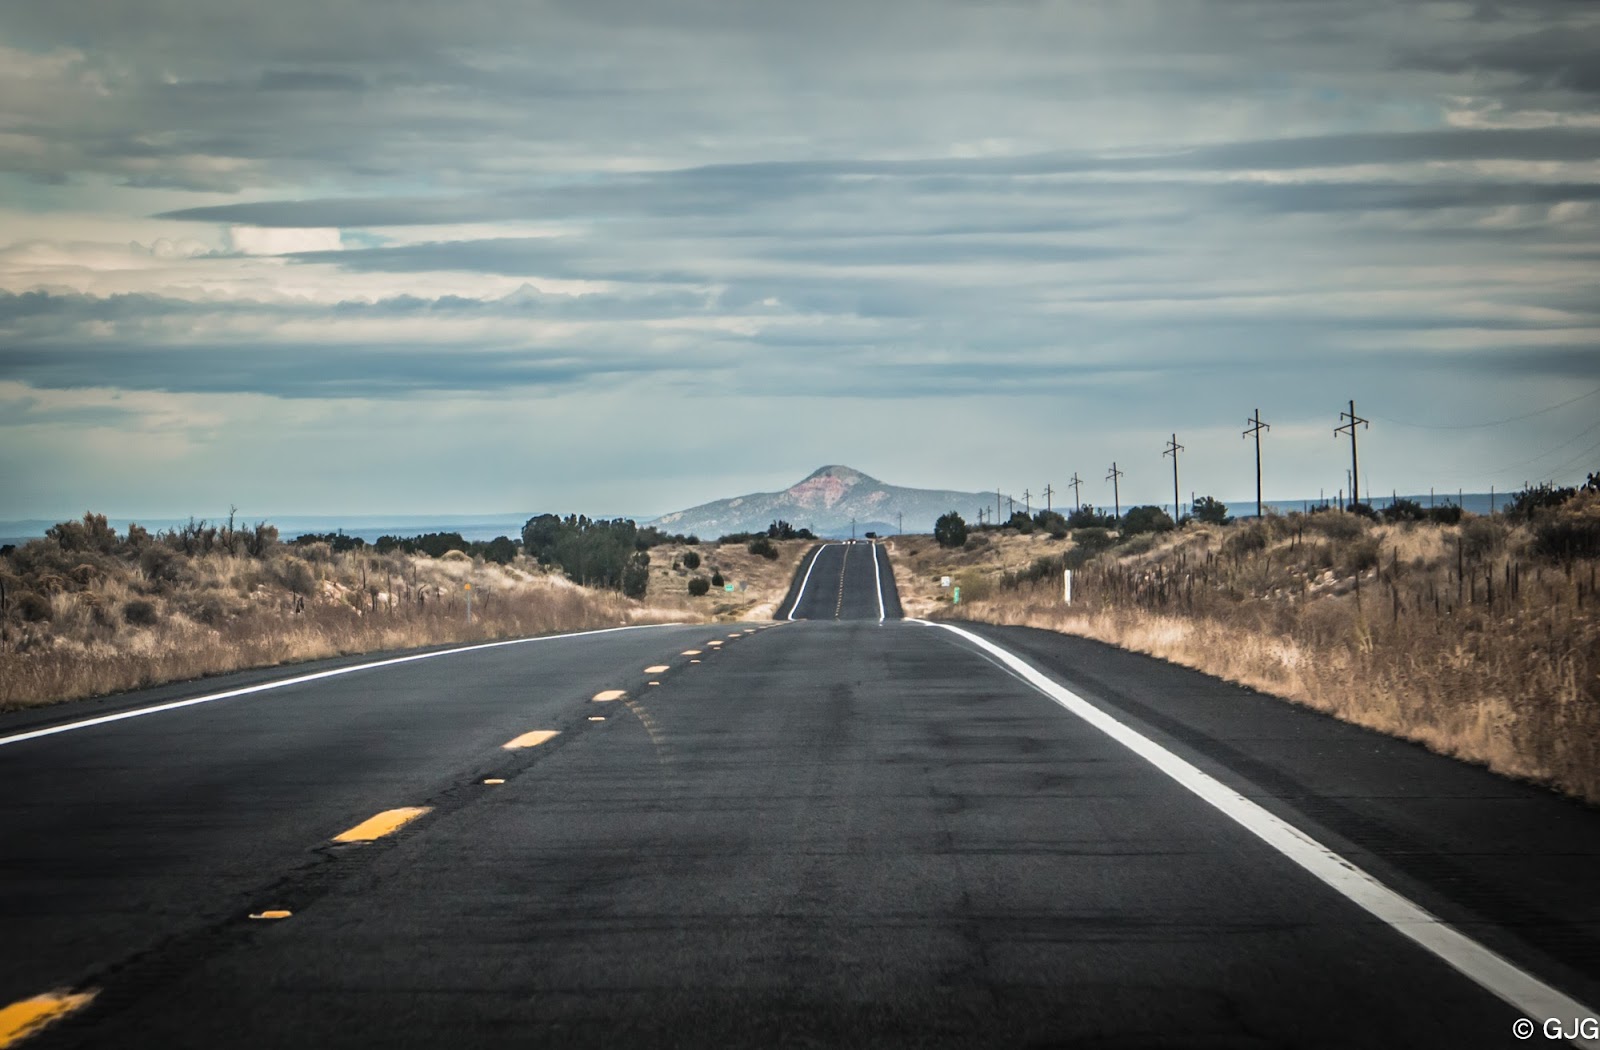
[0,0,1600,519]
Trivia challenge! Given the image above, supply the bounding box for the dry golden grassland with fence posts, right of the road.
[896,496,1600,802]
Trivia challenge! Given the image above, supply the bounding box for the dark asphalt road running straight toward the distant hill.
[0,544,1600,1048]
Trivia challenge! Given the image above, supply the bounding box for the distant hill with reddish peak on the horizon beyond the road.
[645,466,995,539]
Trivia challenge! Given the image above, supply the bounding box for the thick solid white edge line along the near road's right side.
[912,619,1600,1050]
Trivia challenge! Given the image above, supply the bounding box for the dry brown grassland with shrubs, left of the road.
[0,515,808,709]
